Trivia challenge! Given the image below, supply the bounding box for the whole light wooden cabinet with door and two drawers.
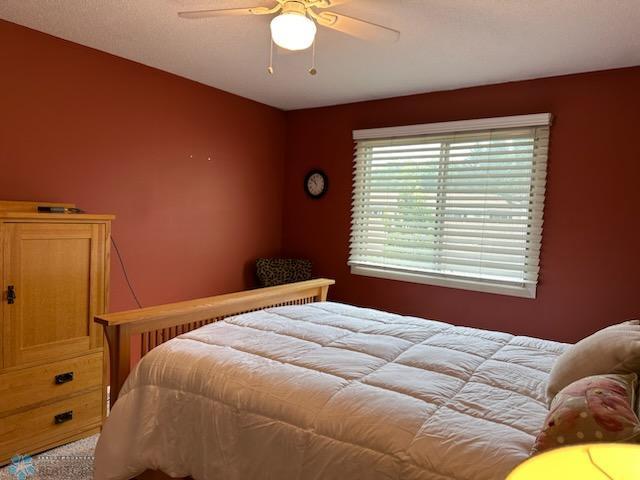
[0,201,113,465]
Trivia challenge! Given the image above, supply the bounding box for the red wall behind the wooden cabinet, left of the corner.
[0,21,285,310]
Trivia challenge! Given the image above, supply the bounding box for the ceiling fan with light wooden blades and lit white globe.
[178,0,400,75]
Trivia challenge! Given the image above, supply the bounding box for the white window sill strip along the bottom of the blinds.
[351,266,536,298]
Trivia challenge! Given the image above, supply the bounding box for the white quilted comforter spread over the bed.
[95,302,565,480]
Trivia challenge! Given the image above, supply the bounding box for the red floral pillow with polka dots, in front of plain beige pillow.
[533,373,640,453]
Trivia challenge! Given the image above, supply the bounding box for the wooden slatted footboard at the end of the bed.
[95,278,335,405]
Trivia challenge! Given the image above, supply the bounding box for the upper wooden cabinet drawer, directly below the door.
[0,353,103,417]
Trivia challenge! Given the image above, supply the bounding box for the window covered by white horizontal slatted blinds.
[349,114,551,298]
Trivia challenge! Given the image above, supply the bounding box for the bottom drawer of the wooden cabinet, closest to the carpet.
[0,389,102,459]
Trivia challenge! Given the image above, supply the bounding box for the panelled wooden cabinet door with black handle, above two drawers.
[3,223,106,368]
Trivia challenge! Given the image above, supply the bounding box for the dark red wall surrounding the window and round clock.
[283,67,640,341]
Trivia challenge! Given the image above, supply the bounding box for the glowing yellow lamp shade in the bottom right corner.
[507,443,640,480]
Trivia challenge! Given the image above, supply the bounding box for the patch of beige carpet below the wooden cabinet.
[0,435,98,480]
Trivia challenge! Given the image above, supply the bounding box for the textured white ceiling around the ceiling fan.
[0,0,640,110]
